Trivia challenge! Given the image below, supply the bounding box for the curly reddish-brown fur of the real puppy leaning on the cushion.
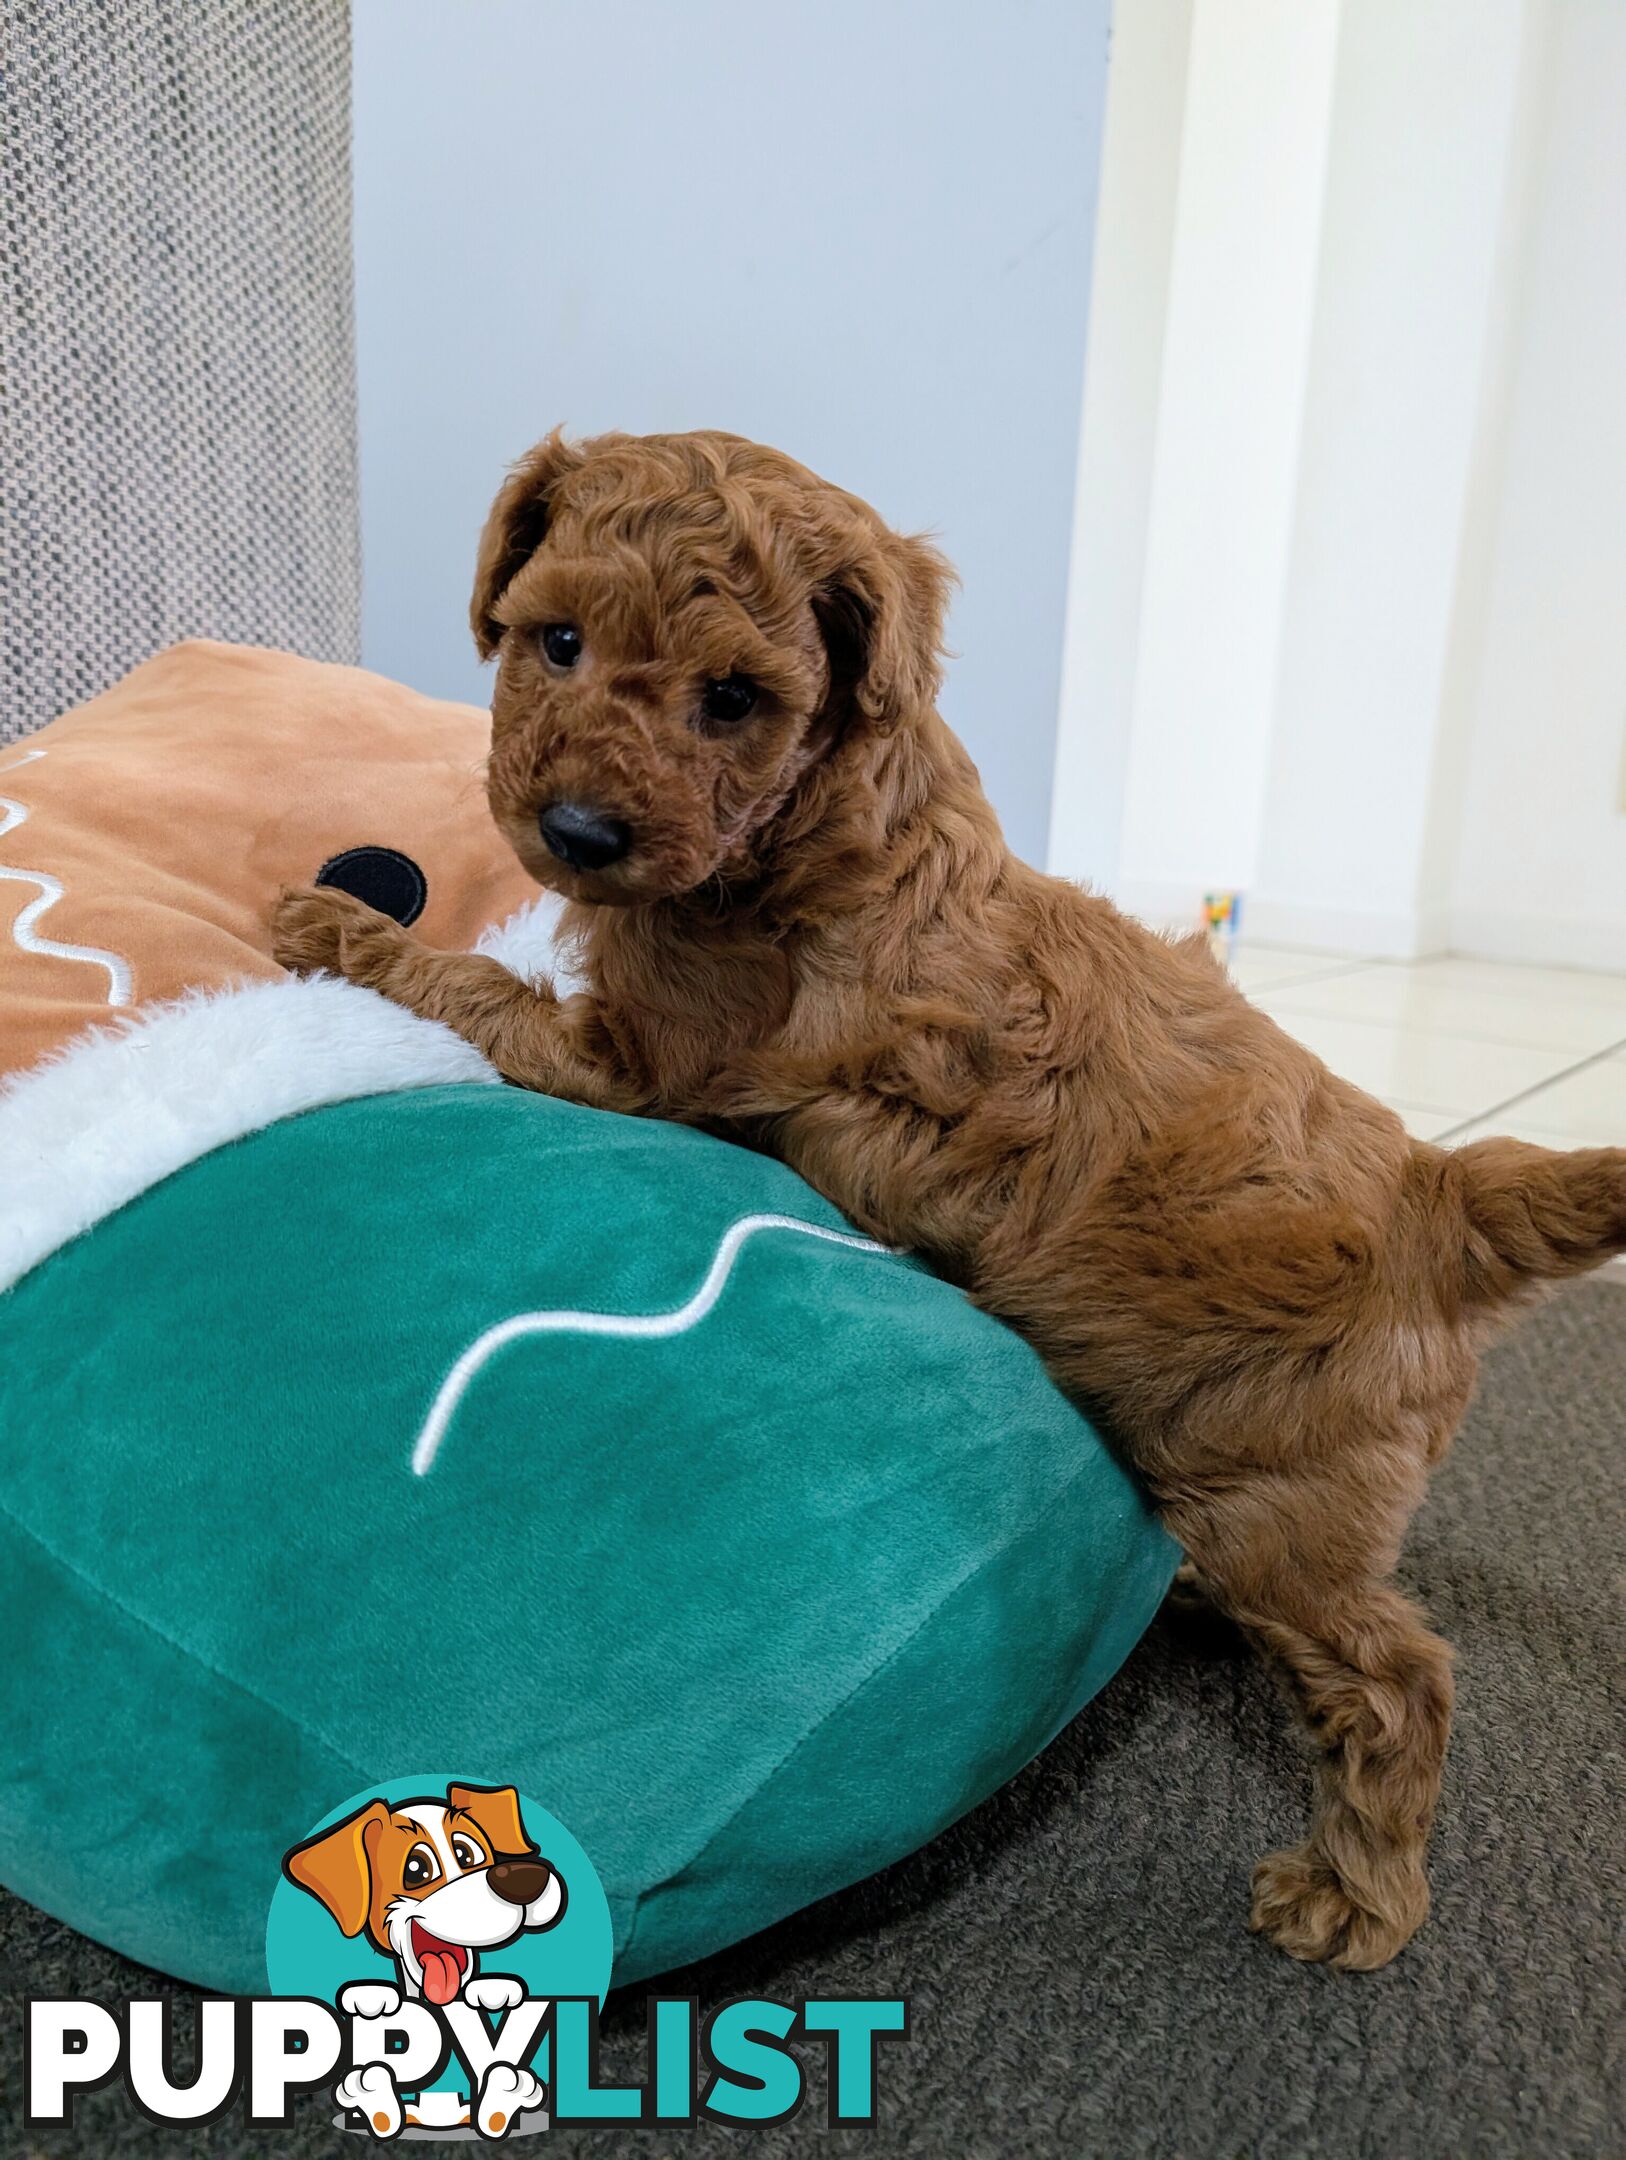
[279,434,1626,1968]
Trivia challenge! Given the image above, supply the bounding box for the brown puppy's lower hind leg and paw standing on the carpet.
[1170,1495,1453,1970]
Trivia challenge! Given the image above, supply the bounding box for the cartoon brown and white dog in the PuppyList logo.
[283,1784,566,2134]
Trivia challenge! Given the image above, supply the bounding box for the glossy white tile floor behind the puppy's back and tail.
[1233,942,1626,1147]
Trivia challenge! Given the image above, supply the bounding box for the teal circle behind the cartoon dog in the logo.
[266,1771,615,2004]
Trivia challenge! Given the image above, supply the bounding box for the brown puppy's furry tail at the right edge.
[1419,1140,1626,1311]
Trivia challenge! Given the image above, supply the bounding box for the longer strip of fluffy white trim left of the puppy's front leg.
[0,976,497,1290]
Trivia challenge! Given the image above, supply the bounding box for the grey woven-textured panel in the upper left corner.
[0,0,361,741]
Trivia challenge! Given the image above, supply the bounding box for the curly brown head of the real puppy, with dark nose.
[471,432,952,905]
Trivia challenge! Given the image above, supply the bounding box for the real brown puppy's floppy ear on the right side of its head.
[812,527,954,734]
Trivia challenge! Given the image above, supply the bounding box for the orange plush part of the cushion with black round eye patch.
[0,642,536,1074]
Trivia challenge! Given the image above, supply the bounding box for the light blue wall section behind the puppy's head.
[354,0,1108,862]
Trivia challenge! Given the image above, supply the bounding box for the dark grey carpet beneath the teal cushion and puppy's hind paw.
[0,1279,1626,2160]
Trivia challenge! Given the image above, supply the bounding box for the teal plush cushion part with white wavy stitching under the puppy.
[0,1086,1177,1989]
